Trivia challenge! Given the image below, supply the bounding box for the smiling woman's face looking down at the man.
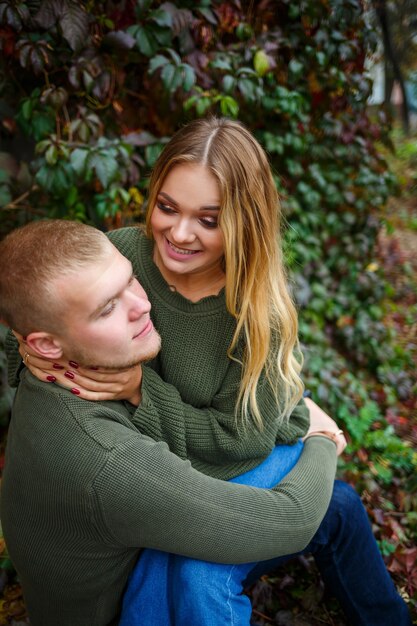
[151,163,224,275]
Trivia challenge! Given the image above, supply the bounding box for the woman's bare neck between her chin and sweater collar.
[153,246,226,302]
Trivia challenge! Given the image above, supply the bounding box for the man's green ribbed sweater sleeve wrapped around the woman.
[94,435,336,563]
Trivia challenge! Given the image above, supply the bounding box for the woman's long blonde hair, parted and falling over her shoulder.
[146,118,303,427]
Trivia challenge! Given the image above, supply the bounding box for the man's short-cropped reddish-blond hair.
[0,220,112,335]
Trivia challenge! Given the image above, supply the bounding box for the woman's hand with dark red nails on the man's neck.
[13,331,142,406]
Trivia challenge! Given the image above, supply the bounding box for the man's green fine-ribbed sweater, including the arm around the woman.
[1,369,336,626]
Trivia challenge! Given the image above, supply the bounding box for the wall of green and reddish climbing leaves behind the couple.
[0,0,411,468]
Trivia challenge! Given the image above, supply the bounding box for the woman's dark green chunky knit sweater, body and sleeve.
[109,228,309,479]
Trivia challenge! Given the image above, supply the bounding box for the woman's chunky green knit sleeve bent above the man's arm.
[132,366,309,480]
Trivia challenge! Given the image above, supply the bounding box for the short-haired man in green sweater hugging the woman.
[0,221,409,626]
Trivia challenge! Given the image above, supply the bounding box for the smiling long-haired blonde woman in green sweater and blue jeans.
[15,118,410,626]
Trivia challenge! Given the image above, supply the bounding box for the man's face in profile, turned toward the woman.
[54,243,160,368]
